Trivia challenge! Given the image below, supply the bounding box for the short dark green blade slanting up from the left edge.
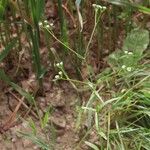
[0,38,17,62]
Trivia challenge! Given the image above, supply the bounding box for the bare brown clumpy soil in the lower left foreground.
[0,83,82,150]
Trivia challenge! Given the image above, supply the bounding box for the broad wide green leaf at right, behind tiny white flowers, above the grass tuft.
[108,29,149,68]
